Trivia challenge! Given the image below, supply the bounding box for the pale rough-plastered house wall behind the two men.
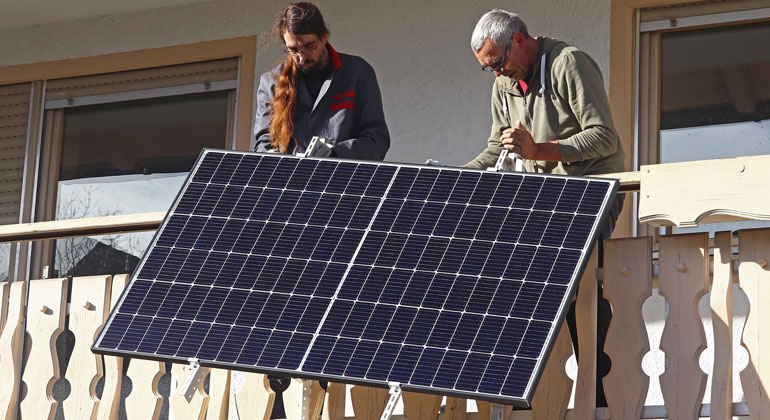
[0,0,610,164]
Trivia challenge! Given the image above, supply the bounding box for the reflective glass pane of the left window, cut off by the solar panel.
[54,91,229,276]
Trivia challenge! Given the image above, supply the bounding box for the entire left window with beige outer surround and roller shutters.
[0,36,256,281]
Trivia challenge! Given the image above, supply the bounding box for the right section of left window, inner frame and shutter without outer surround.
[34,60,238,276]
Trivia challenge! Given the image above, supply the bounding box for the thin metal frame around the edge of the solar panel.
[91,149,619,407]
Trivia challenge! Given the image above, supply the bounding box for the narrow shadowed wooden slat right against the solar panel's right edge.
[575,246,599,419]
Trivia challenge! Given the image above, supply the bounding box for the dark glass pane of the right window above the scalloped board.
[660,22,770,234]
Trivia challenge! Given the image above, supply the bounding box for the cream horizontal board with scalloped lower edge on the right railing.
[639,155,770,227]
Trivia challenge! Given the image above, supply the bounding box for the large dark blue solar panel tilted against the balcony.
[93,150,617,405]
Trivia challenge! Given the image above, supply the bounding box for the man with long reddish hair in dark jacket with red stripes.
[254,2,390,160]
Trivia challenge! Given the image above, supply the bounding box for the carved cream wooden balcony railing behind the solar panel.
[0,156,770,420]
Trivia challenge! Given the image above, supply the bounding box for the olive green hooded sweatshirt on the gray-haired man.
[465,37,625,175]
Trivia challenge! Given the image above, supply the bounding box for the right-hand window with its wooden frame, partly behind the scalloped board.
[638,3,770,234]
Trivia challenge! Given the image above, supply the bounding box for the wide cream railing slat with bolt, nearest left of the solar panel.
[62,276,111,419]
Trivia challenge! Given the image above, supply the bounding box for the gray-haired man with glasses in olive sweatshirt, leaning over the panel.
[465,9,625,406]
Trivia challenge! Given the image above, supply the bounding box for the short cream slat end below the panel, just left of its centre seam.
[232,372,272,420]
